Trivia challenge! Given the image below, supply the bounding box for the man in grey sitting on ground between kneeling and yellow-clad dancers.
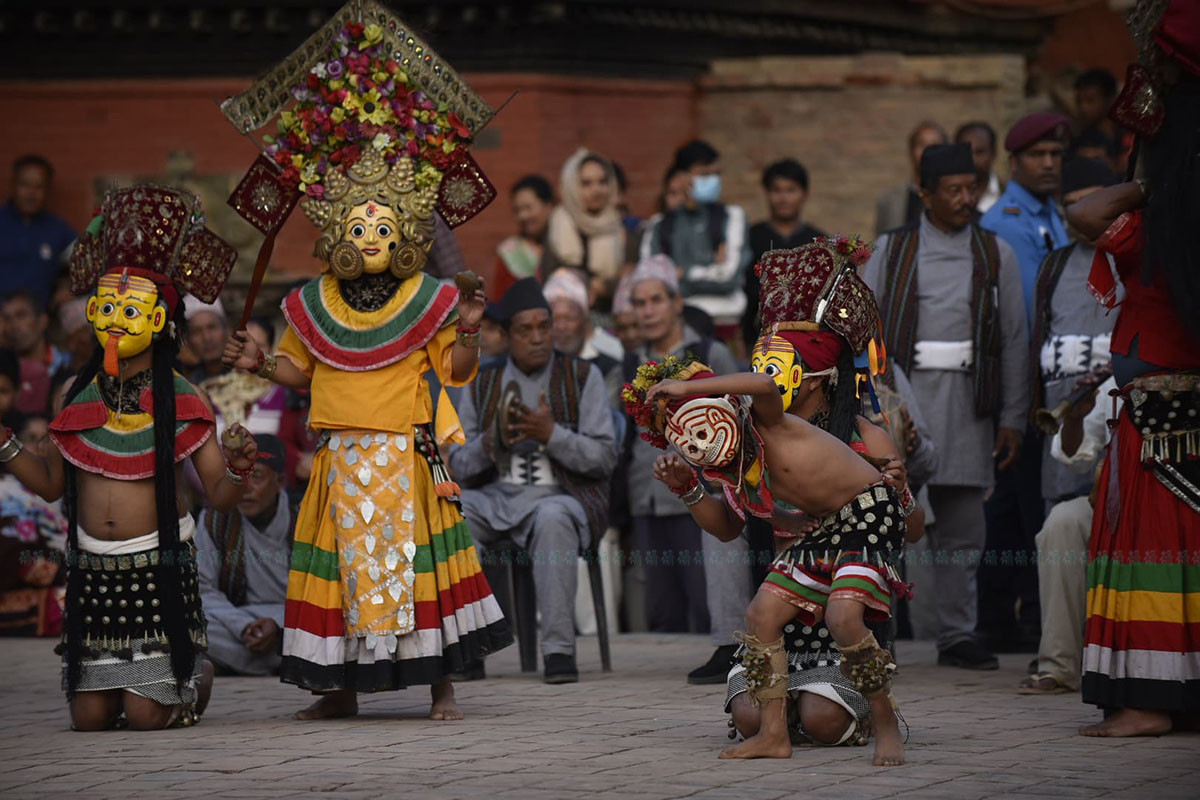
[196,434,295,675]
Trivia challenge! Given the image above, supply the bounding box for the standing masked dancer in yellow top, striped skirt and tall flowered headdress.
[223,1,512,720]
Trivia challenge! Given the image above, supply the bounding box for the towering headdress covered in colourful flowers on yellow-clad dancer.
[221,0,496,286]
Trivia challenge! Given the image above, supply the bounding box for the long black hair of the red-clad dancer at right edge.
[1139,76,1200,338]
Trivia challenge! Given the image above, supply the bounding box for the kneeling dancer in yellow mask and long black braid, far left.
[0,186,257,730]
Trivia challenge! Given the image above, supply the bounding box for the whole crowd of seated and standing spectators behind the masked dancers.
[0,65,1129,692]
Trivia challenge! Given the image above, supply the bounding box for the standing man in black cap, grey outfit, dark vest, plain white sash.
[863,144,1030,669]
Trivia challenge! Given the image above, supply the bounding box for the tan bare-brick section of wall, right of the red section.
[700,53,1025,235]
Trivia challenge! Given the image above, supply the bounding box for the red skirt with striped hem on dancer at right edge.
[1081,403,1200,712]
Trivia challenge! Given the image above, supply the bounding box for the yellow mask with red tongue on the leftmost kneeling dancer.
[86,272,167,377]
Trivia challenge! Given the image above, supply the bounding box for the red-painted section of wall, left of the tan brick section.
[0,74,695,291]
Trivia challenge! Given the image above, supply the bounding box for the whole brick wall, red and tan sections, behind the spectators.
[0,54,1025,297]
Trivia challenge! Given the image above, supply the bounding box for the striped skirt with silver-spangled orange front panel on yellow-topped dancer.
[280,427,512,692]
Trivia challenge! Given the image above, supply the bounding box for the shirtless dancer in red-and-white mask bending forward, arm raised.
[624,359,905,766]
